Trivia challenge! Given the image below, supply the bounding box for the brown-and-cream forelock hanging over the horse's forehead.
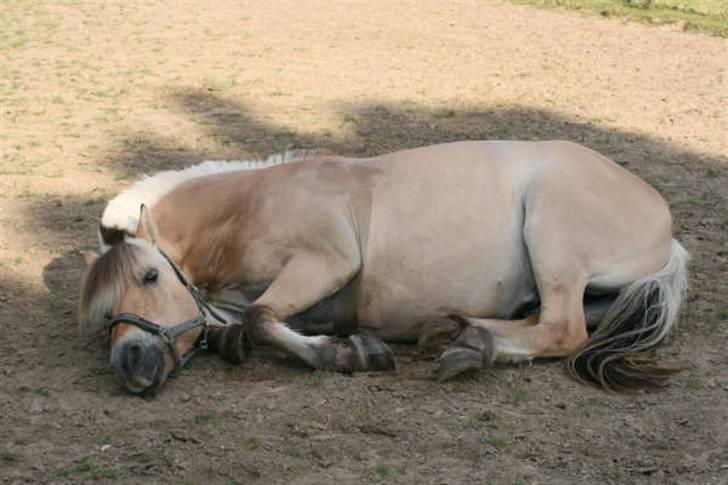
[78,242,141,333]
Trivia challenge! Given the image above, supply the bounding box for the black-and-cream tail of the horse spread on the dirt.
[568,239,690,391]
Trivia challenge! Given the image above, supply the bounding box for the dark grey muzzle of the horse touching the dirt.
[111,332,167,394]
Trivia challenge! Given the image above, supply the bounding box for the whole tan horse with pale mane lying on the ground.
[79,141,688,393]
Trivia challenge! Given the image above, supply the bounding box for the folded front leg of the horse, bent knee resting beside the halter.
[240,253,395,372]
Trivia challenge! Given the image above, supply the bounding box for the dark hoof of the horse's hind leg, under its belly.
[437,326,495,382]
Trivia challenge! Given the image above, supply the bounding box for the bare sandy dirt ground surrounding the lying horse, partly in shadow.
[0,0,728,484]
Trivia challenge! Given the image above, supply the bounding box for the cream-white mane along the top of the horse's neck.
[100,150,324,246]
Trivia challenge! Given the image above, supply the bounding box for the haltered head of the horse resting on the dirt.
[78,204,220,394]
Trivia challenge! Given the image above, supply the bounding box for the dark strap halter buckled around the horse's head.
[109,247,232,371]
